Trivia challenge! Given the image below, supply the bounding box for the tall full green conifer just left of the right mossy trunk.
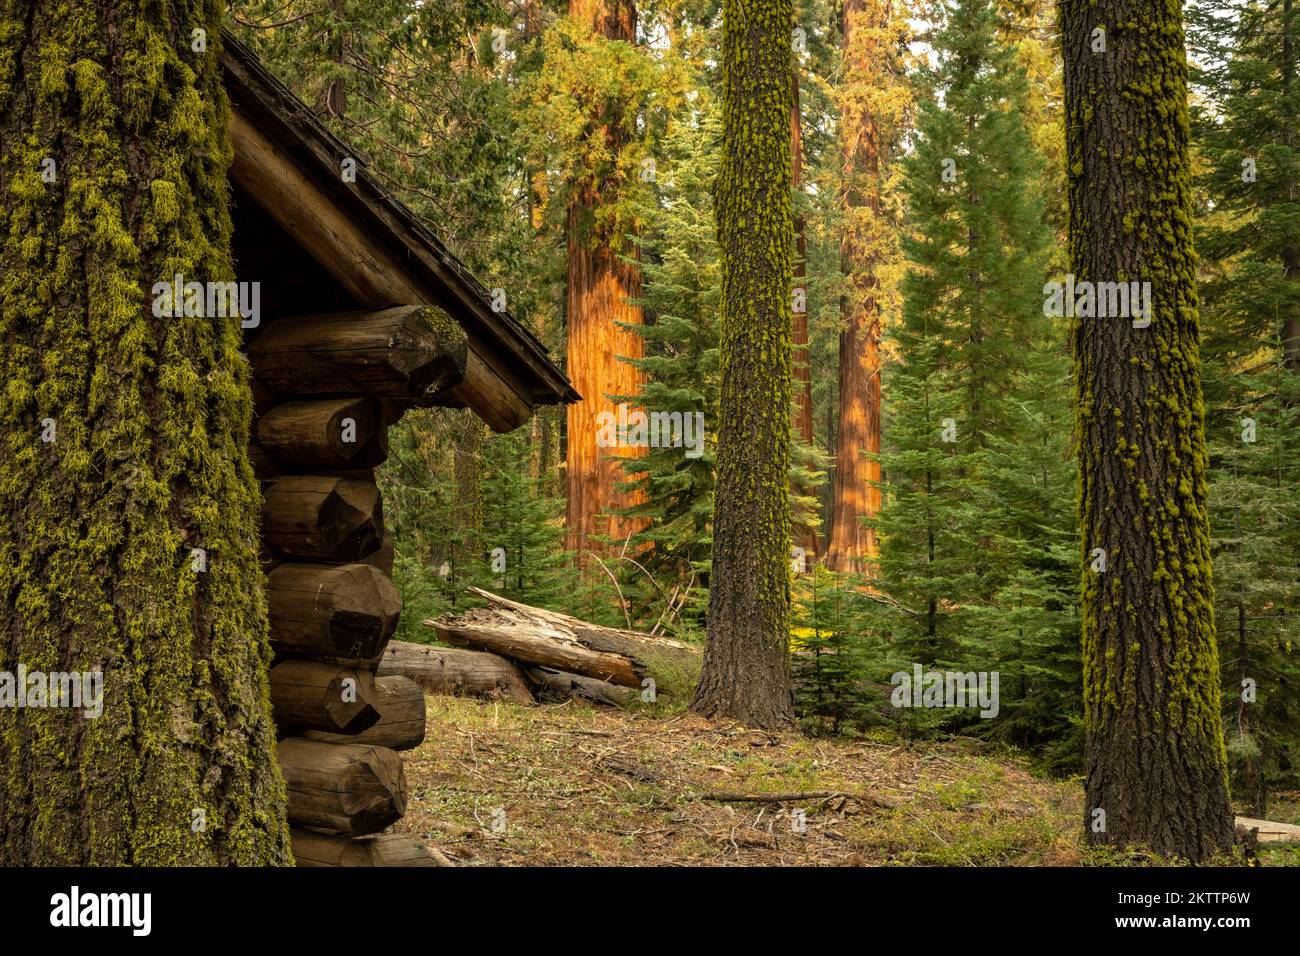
[875,0,1063,670]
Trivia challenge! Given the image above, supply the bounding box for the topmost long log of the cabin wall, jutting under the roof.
[248,306,468,399]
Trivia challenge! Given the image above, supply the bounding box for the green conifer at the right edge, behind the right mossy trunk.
[1190,0,1300,817]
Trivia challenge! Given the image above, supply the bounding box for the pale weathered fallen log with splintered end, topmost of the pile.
[424,588,699,691]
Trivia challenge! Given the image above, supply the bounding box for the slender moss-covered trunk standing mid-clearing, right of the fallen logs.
[692,0,794,728]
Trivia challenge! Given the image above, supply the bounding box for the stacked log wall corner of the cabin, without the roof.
[239,297,431,866]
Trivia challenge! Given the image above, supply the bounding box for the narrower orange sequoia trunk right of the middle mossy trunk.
[826,0,889,574]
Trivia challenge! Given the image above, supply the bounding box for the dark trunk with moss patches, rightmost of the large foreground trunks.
[1061,0,1232,860]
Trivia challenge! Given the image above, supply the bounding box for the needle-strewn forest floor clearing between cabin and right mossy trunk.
[397,696,1300,866]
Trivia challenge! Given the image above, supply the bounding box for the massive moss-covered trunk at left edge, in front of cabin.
[0,0,289,865]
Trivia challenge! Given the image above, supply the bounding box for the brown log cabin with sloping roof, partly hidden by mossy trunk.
[222,34,579,866]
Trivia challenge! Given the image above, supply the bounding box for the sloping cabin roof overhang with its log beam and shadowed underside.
[222,34,580,431]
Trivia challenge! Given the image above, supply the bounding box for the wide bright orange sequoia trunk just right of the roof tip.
[566,0,645,563]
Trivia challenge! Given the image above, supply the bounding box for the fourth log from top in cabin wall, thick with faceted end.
[267,563,402,670]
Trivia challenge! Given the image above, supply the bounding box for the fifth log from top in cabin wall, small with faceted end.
[270,661,379,743]
